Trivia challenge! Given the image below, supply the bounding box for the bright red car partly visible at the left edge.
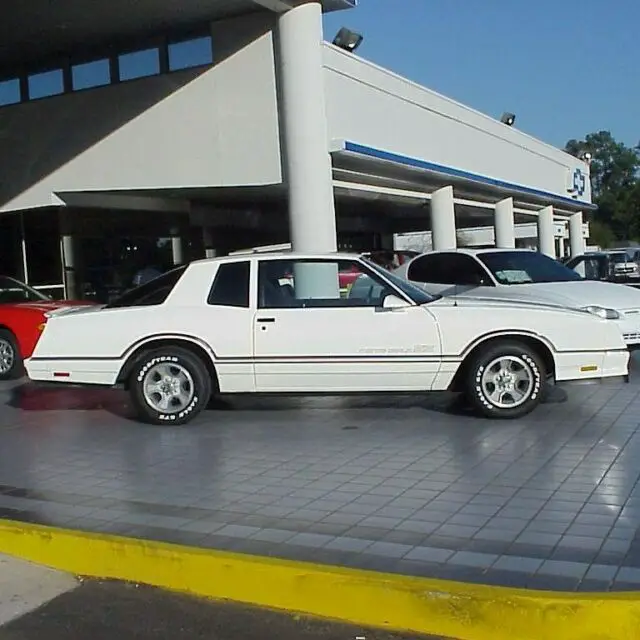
[0,276,91,380]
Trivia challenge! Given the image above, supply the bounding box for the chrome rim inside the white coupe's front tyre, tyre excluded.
[480,355,536,409]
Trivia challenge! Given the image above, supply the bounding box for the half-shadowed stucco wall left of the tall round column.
[0,15,281,211]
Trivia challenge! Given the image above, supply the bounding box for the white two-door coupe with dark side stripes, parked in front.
[25,253,629,425]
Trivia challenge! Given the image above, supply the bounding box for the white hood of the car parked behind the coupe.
[425,280,640,309]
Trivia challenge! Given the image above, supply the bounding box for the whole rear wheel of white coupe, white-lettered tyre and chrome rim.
[129,346,211,426]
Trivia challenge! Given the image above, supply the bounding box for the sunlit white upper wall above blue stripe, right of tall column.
[324,44,591,202]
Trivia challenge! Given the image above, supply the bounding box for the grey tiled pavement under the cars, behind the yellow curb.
[0,362,640,590]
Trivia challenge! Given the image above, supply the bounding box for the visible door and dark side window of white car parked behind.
[407,252,493,296]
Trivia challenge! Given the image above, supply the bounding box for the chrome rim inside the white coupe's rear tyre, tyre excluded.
[142,362,195,414]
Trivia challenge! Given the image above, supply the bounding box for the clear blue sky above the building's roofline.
[325,0,640,146]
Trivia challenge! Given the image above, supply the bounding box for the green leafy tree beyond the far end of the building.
[565,131,640,240]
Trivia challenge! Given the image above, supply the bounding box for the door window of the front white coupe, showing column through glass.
[258,259,395,309]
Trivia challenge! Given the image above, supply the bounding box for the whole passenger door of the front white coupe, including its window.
[254,258,440,392]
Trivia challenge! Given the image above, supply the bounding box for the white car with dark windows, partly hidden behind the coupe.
[394,249,640,349]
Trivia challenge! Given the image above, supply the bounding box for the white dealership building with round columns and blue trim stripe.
[0,0,593,297]
